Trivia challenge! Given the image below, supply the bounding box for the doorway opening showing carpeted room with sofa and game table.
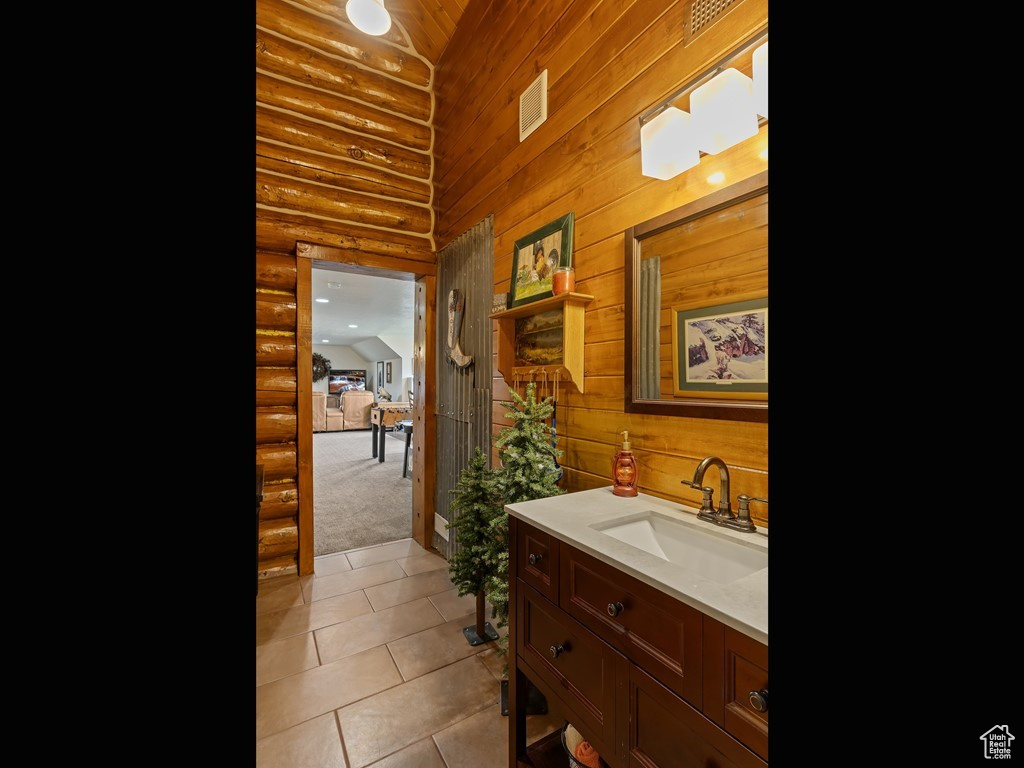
[309,259,416,556]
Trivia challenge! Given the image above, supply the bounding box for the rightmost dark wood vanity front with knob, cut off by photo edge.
[705,616,768,760]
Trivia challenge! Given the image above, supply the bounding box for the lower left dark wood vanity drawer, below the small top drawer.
[515,580,629,755]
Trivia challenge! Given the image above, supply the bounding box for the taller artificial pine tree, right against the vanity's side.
[485,382,565,667]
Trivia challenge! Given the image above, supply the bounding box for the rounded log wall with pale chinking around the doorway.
[255,0,434,575]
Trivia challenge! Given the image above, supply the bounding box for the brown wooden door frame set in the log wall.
[295,241,437,575]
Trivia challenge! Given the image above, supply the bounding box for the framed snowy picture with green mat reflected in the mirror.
[672,297,768,398]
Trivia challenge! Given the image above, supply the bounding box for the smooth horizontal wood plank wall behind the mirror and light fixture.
[434,0,768,525]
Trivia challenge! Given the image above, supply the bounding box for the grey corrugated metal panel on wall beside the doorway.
[433,216,495,557]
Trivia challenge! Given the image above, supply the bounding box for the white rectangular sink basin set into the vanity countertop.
[591,510,768,584]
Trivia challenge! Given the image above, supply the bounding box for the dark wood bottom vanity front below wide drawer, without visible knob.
[629,666,768,768]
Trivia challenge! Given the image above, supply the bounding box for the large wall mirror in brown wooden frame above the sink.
[626,171,768,422]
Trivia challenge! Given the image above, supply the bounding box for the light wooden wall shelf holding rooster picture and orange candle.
[489,293,594,393]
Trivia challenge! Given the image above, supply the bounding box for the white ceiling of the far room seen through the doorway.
[312,269,416,346]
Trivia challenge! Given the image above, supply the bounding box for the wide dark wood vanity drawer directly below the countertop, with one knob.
[559,542,703,708]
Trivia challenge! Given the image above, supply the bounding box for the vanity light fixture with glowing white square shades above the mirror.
[640,29,768,179]
